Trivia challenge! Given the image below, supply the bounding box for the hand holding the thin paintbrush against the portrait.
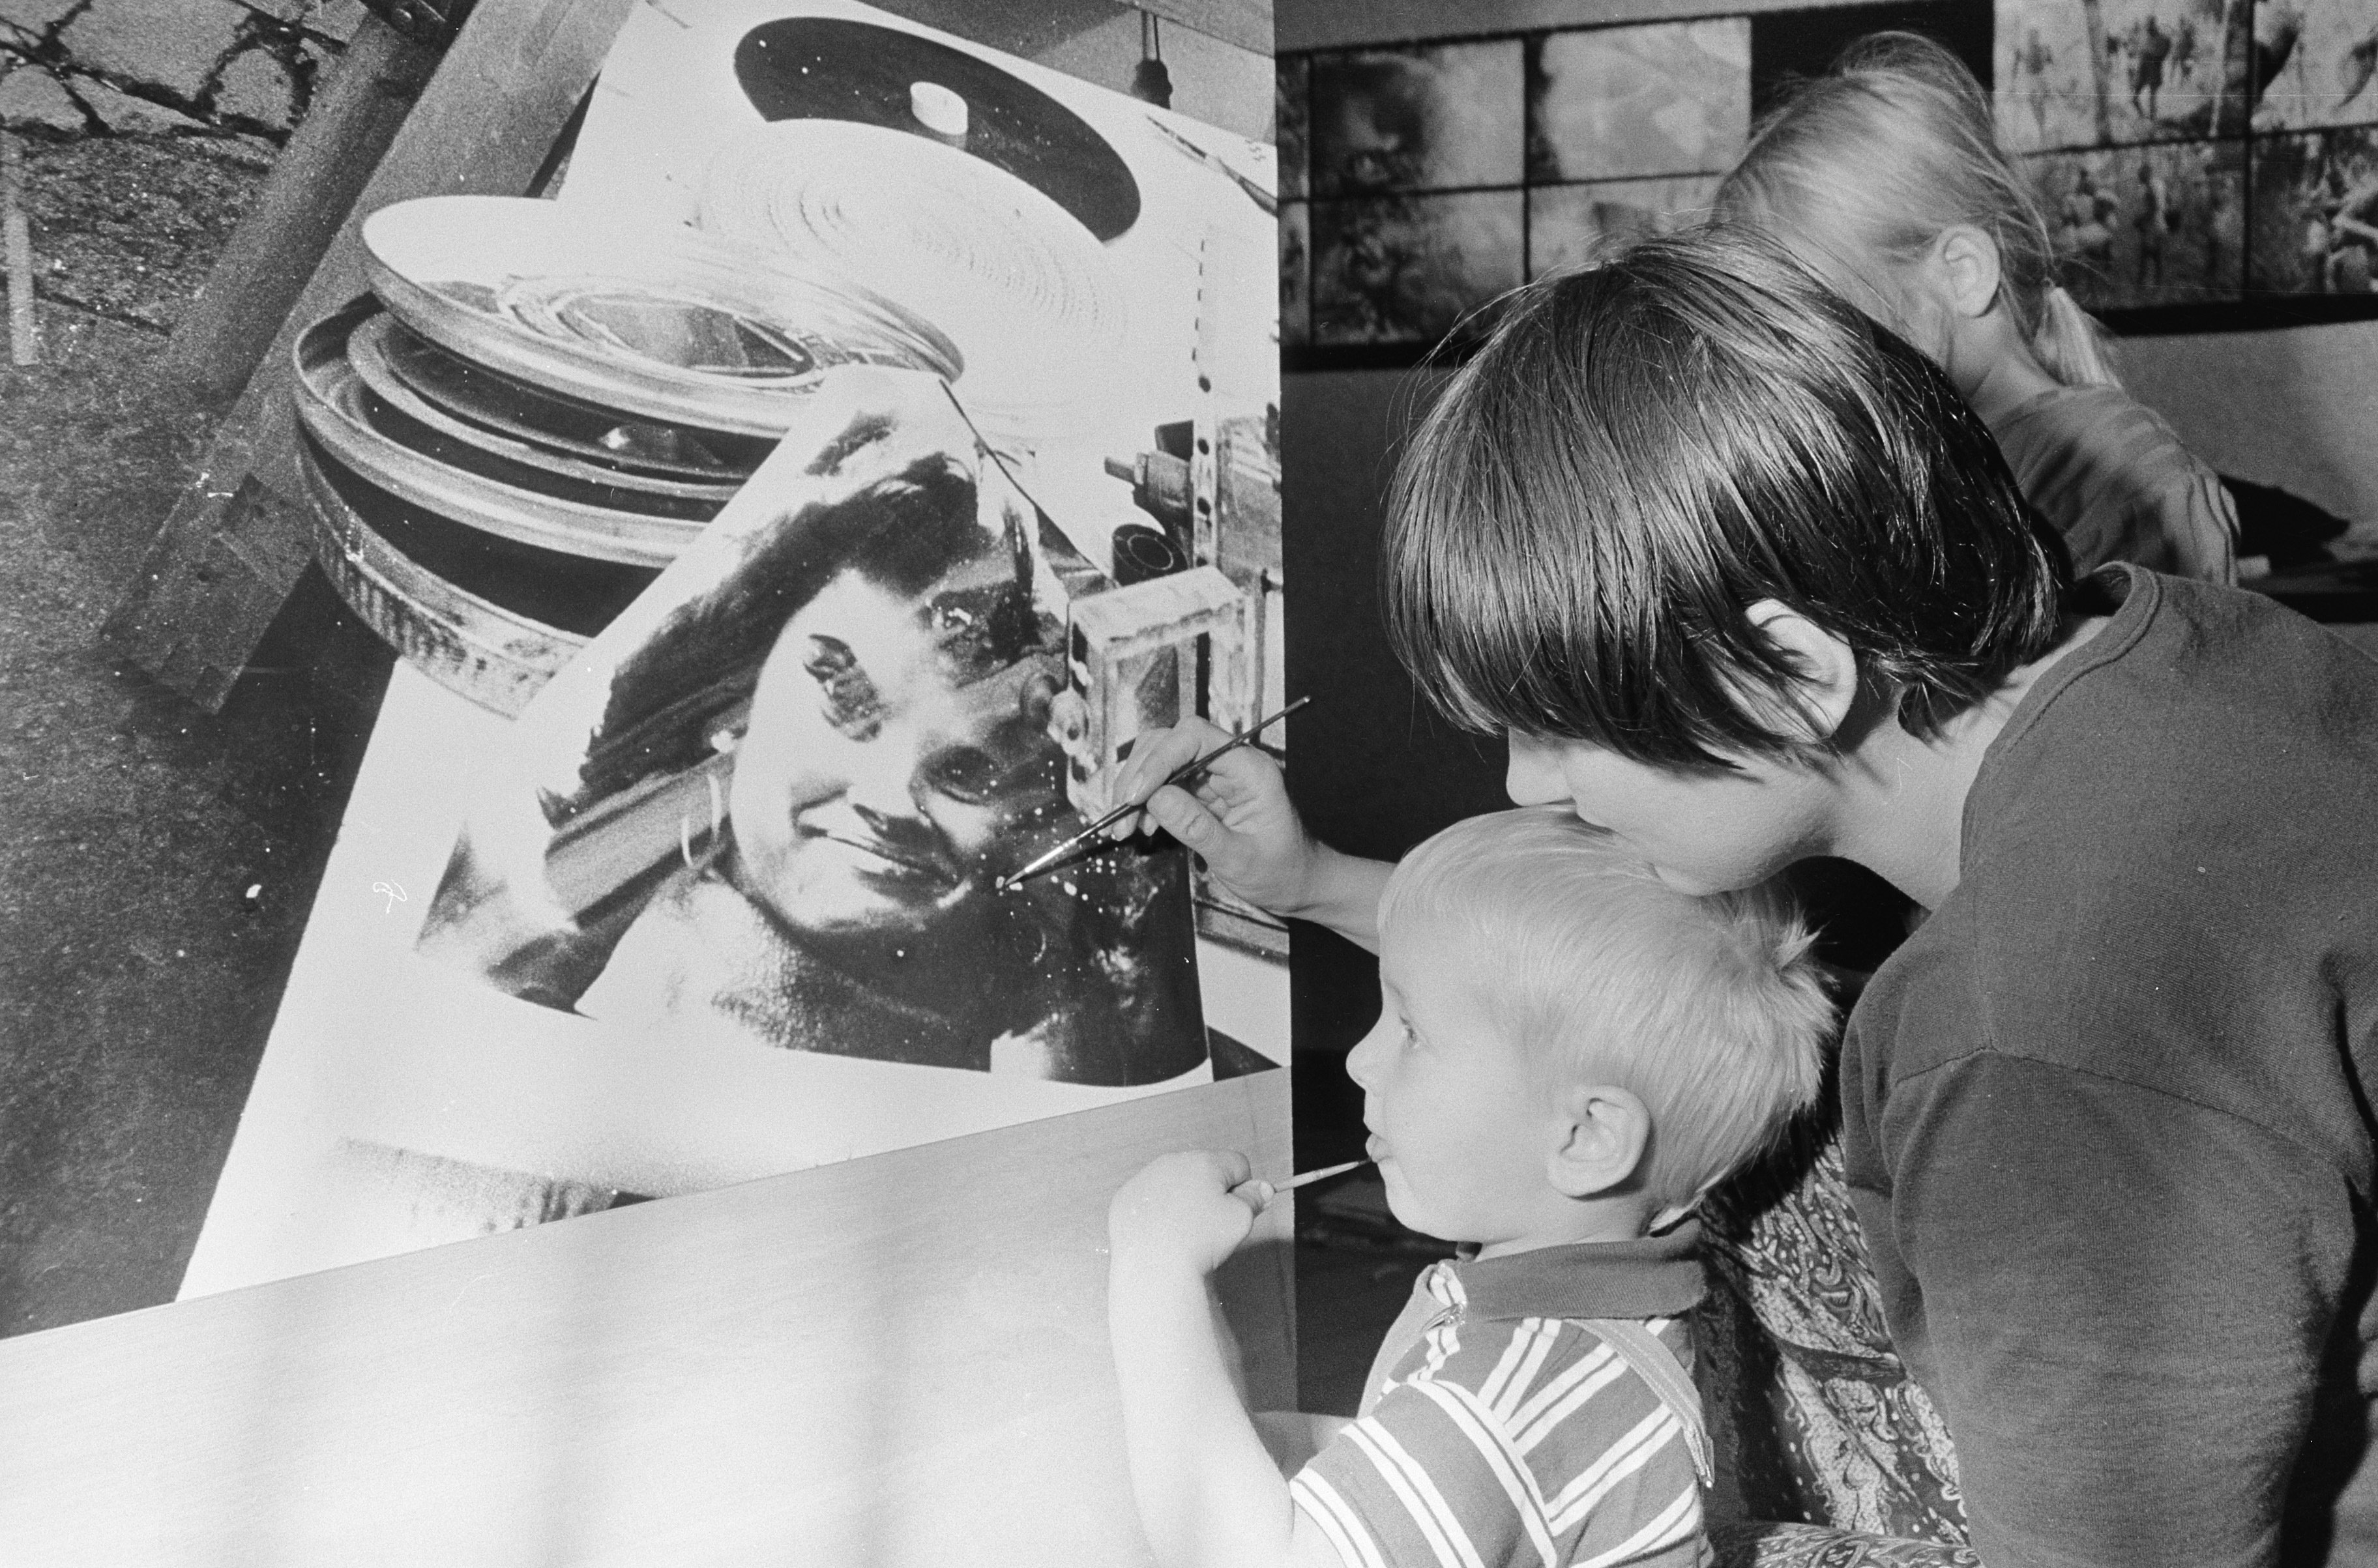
[1108,720,1322,915]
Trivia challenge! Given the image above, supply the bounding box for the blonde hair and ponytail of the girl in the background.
[1714,33,2121,387]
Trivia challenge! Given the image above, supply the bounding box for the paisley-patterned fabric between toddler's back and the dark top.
[1693,1107,1978,1568]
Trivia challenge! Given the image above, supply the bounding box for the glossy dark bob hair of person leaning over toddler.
[1381,225,2069,772]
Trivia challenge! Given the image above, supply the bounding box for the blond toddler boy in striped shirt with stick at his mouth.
[1108,807,1834,1568]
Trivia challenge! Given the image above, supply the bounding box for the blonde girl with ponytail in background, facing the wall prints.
[1714,33,2238,582]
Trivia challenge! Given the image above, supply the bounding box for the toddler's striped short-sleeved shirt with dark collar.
[1289,1226,1707,1568]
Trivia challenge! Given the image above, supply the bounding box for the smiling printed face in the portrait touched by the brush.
[727,563,1061,934]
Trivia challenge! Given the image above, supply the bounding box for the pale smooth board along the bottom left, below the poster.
[0,1074,1294,1568]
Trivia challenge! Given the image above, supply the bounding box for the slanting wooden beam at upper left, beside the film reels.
[107,0,635,713]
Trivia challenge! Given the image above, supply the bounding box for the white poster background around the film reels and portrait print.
[183,0,1289,1297]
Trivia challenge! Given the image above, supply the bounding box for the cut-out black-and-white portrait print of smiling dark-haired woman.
[421,390,1206,1086]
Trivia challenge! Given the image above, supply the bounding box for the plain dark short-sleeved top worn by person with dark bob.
[1843,568,2378,1568]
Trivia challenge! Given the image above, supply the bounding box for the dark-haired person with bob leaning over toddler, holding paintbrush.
[1120,228,2378,1568]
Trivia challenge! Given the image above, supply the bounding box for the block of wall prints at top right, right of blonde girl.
[1995,0,2378,330]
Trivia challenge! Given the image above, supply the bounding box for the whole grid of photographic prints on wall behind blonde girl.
[1280,0,2378,368]
